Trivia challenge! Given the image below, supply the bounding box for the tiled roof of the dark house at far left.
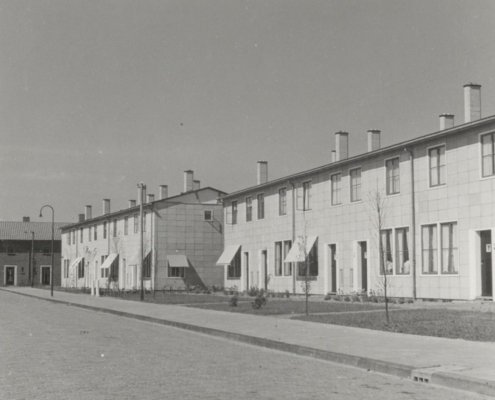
[0,221,67,240]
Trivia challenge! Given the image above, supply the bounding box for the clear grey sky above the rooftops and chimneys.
[0,0,495,222]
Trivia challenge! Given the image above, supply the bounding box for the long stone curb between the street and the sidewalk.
[0,288,495,396]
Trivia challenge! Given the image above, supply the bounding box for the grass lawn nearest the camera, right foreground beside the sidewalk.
[295,308,495,342]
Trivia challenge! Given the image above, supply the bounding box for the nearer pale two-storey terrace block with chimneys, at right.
[218,84,495,299]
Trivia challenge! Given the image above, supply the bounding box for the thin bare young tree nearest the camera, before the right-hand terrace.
[368,189,391,324]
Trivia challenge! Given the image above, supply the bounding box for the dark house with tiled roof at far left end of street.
[0,217,65,286]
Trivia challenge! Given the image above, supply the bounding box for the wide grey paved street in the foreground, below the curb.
[0,291,489,400]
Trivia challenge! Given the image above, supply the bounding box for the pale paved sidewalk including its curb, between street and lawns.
[2,287,495,396]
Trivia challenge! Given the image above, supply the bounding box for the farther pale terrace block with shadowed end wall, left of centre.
[62,171,225,290]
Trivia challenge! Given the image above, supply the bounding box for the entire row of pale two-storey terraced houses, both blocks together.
[20,84,495,299]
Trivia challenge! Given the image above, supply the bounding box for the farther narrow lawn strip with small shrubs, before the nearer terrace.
[191,296,383,315]
